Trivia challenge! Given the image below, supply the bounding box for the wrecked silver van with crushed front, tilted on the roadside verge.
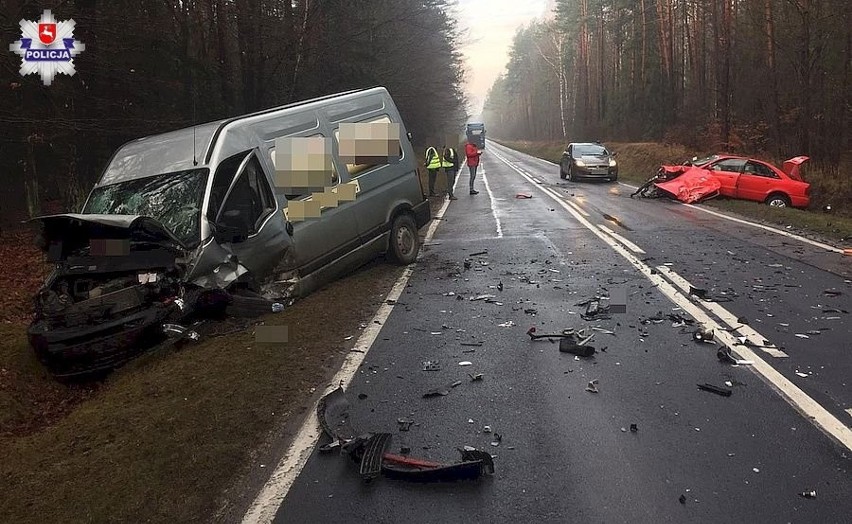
[28,87,431,376]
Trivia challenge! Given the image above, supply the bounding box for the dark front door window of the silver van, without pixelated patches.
[216,151,275,234]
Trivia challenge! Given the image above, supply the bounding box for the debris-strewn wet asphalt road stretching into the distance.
[276,142,852,523]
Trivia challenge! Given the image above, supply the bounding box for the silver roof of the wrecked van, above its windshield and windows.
[97,87,387,186]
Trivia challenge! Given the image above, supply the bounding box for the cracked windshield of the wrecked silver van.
[83,169,208,246]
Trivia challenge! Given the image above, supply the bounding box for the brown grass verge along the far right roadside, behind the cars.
[499,141,852,248]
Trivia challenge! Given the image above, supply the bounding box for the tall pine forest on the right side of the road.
[486,0,852,173]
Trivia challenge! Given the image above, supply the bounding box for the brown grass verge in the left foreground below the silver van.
[0,262,402,522]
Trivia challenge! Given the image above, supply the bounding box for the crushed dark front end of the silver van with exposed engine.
[27,214,290,377]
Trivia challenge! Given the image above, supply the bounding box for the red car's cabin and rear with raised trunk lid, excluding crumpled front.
[660,155,810,208]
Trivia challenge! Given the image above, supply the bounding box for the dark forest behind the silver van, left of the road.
[0,0,465,224]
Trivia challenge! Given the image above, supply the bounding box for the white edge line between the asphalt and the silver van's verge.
[242,200,450,524]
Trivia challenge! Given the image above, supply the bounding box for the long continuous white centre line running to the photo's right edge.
[495,148,852,451]
